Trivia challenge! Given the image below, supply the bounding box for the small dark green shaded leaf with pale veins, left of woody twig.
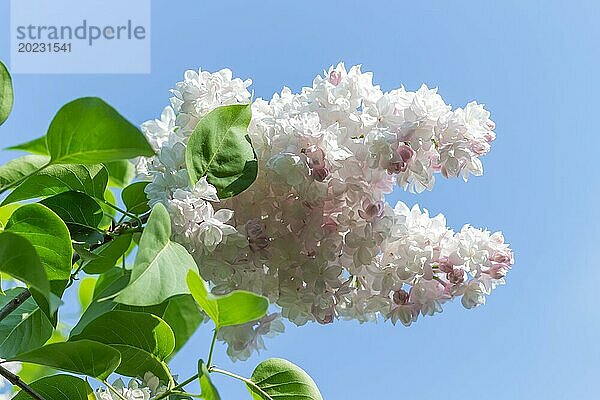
[40,192,104,240]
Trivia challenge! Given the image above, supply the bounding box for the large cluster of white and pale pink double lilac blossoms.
[138,64,513,359]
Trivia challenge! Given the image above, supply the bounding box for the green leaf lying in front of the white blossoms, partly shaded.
[185,104,258,199]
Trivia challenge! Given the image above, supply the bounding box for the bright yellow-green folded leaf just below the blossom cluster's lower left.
[186,271,269,329]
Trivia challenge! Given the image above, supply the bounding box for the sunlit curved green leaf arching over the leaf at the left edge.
[5,204,73,281]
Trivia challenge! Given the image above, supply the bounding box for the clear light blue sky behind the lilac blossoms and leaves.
[0,0,600,400]
